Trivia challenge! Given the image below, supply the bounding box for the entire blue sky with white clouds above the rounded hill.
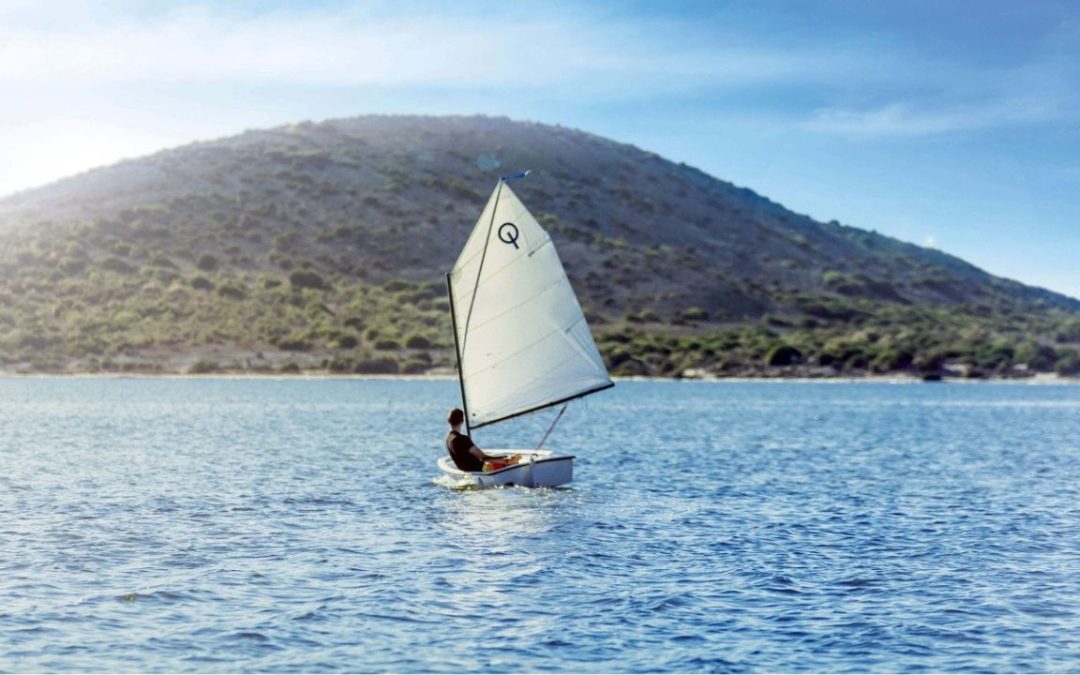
[0,0,1080,297]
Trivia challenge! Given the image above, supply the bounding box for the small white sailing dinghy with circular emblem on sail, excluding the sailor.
[438,172,615,487]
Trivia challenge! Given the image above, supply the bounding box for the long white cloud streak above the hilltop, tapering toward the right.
[0,6,868,92]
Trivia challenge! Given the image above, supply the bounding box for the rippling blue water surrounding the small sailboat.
[0,379,1080,672]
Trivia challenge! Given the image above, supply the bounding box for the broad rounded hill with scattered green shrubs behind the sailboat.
[0,117,1080,375]
